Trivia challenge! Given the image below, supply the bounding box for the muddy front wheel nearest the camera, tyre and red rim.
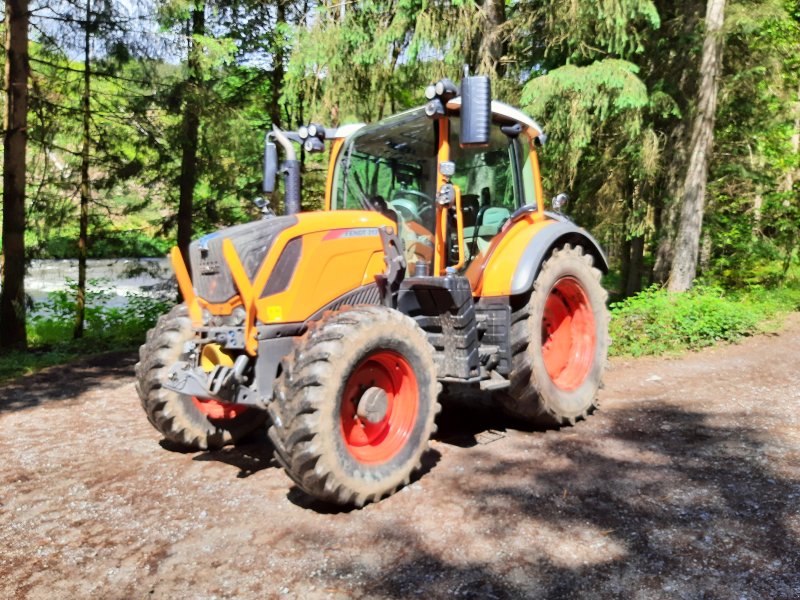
[269,306,441,506]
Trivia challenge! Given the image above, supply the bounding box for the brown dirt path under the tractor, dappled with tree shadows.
[0,315,800,599]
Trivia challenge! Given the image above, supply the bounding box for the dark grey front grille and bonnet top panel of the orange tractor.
[189,216,297,304]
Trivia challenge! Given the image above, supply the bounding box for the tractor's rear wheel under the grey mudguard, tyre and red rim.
[497,244,609,426]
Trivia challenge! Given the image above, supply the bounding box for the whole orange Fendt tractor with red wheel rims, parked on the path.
[136,77,609,506]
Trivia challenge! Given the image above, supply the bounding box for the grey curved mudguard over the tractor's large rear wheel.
[511,218,608,295]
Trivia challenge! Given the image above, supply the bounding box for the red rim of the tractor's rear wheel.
[542,277,597,392]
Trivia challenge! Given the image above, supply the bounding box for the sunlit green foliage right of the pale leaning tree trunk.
[704,0,800,287]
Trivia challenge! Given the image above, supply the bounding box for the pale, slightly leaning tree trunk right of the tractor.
[668,0,725,292]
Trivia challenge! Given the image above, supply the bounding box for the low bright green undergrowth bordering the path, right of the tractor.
[609,284,800,356]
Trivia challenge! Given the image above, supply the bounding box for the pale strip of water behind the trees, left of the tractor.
[25,258,176,312]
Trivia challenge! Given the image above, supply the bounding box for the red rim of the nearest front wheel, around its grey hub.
[340,350,419,464]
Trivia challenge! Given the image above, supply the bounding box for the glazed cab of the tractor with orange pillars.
[326,97,541,275]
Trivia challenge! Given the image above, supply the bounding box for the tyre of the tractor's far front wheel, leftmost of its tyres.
[136,304,266,450]
